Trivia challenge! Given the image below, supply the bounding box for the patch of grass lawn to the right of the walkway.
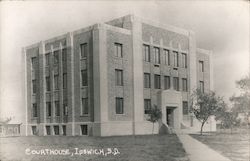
[191,129,250,161]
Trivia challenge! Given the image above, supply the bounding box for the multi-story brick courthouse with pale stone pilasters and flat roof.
[23,15,214,136]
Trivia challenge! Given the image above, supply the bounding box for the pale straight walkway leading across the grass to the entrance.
[177,133,230,161]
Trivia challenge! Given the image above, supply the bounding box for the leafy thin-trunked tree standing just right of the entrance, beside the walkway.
[190,90,226,135]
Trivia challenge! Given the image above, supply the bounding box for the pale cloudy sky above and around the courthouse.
[0,0,250,122]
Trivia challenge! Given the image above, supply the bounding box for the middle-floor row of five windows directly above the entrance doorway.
[144,73,188,92]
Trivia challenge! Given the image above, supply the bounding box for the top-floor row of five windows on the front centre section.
[143,44,187,68]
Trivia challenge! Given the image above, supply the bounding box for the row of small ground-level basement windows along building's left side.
[31,125,88,135]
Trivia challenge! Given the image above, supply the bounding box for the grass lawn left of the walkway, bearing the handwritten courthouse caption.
[0,135,188,161]
